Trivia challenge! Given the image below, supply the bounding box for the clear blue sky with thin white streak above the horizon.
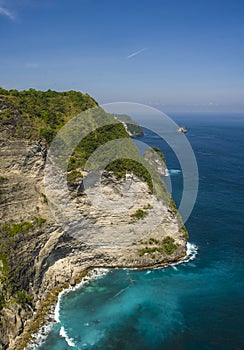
[0,0,244,111]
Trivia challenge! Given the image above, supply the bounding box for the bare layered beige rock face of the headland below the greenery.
[0,88,187,350]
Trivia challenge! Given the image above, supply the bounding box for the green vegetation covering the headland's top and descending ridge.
[0,88,170,203]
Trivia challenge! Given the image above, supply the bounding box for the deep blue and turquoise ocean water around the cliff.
[36,113,244,350]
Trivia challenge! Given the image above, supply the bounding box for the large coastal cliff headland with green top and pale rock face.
[0,89,187,350]
